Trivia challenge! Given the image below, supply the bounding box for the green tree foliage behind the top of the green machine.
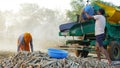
[66,0,120,21]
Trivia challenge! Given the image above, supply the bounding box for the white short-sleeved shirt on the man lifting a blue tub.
[93,15,106,35]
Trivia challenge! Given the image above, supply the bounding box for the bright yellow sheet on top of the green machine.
[96,2,120,24]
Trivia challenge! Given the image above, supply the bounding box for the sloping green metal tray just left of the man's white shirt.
[70,20,95,36]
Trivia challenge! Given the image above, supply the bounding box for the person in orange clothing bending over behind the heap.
[17,32,33,52]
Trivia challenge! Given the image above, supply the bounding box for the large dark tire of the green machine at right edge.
[108,41,120,60]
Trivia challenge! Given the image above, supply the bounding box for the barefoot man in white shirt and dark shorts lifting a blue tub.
[83,8,111,64]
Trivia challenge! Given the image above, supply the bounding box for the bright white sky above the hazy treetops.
[0,0,120,11]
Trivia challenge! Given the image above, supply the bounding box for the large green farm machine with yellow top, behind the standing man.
[59,2,120,60]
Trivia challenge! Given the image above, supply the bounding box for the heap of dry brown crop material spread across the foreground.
[0,51,112,68]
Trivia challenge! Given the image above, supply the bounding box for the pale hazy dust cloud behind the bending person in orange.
[0,3,68,51]
